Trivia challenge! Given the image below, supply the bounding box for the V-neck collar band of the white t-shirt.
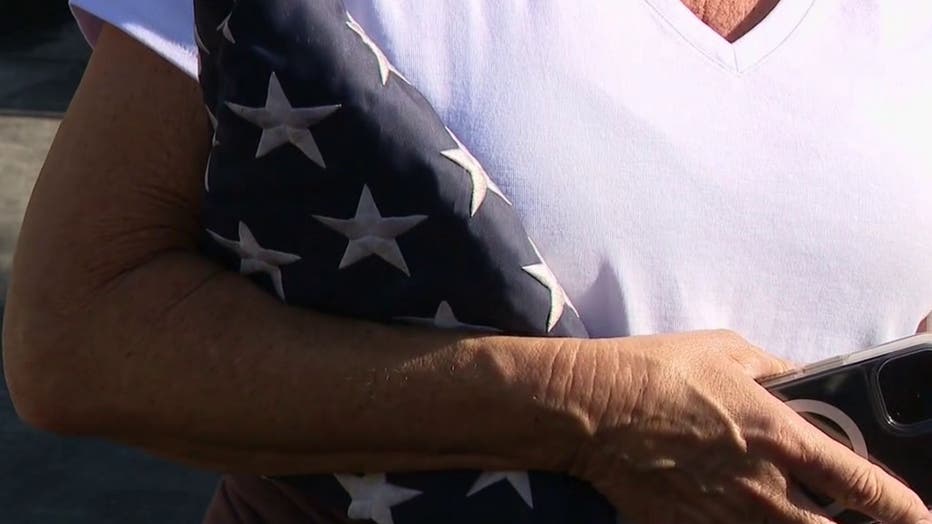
[645,0,815,73]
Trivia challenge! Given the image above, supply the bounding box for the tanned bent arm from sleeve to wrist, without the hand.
[4,24,587,473]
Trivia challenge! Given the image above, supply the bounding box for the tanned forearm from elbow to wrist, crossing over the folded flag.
[7,253,608,474]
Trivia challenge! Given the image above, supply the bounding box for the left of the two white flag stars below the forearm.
[334,473,421,524]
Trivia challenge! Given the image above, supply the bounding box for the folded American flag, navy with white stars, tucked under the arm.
[194,0,615,524]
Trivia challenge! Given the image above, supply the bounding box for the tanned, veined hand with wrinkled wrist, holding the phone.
[572,331,929,524]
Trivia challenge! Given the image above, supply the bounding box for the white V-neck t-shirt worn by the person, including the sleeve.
[72,0,932,362]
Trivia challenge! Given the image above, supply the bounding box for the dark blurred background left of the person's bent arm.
[0,4,216,524]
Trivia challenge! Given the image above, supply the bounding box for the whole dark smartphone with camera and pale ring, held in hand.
[764,334,932,524]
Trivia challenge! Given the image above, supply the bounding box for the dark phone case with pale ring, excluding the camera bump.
[768,336,932,524]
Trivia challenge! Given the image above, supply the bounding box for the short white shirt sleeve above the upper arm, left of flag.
[69,0,198,77]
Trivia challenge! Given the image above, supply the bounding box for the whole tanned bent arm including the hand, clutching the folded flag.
[3,22,928,524]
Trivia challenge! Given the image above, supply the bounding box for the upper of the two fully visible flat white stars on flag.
[227,73,340,168]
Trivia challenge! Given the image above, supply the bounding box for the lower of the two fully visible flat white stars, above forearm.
[314,186,427,276]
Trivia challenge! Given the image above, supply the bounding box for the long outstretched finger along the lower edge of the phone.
[784,408,930,524]
